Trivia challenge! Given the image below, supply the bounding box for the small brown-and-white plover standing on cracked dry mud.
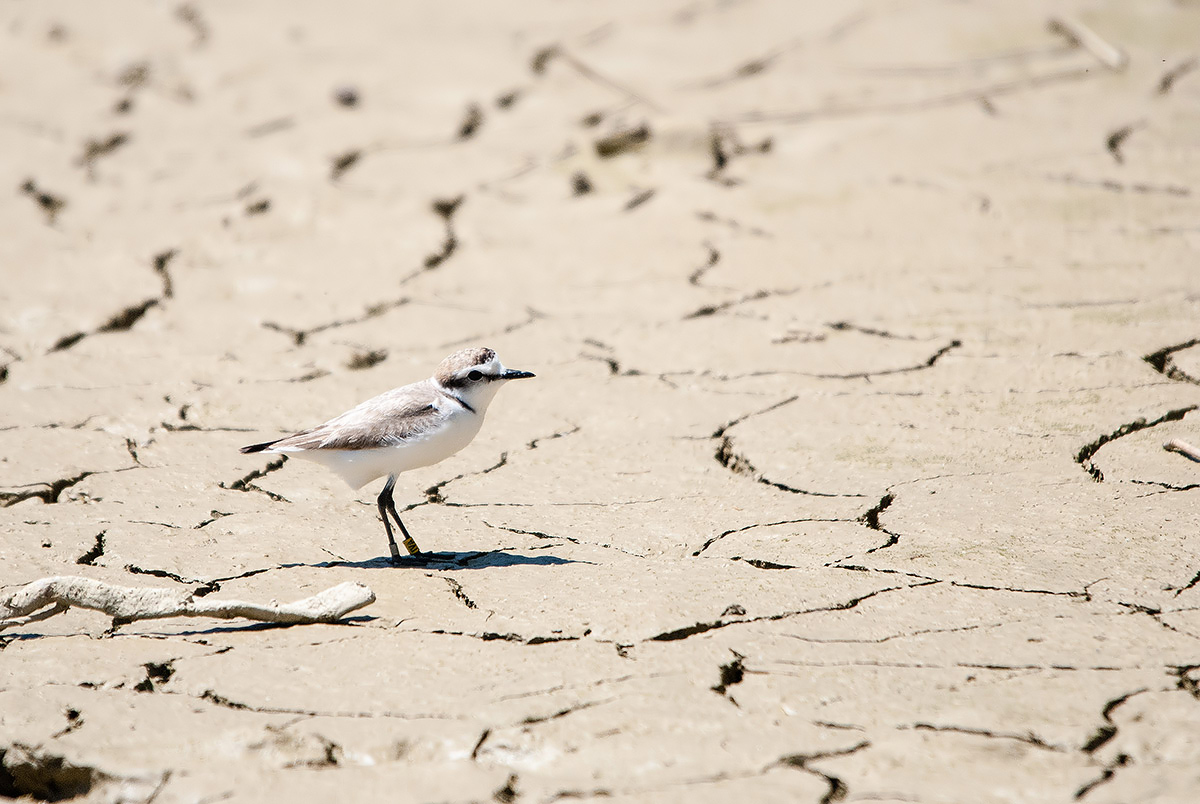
[241,348,534,560]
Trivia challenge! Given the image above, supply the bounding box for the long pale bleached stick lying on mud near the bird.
[0,575,376,630]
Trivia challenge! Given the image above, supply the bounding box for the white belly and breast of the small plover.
[287,412,484,488]
